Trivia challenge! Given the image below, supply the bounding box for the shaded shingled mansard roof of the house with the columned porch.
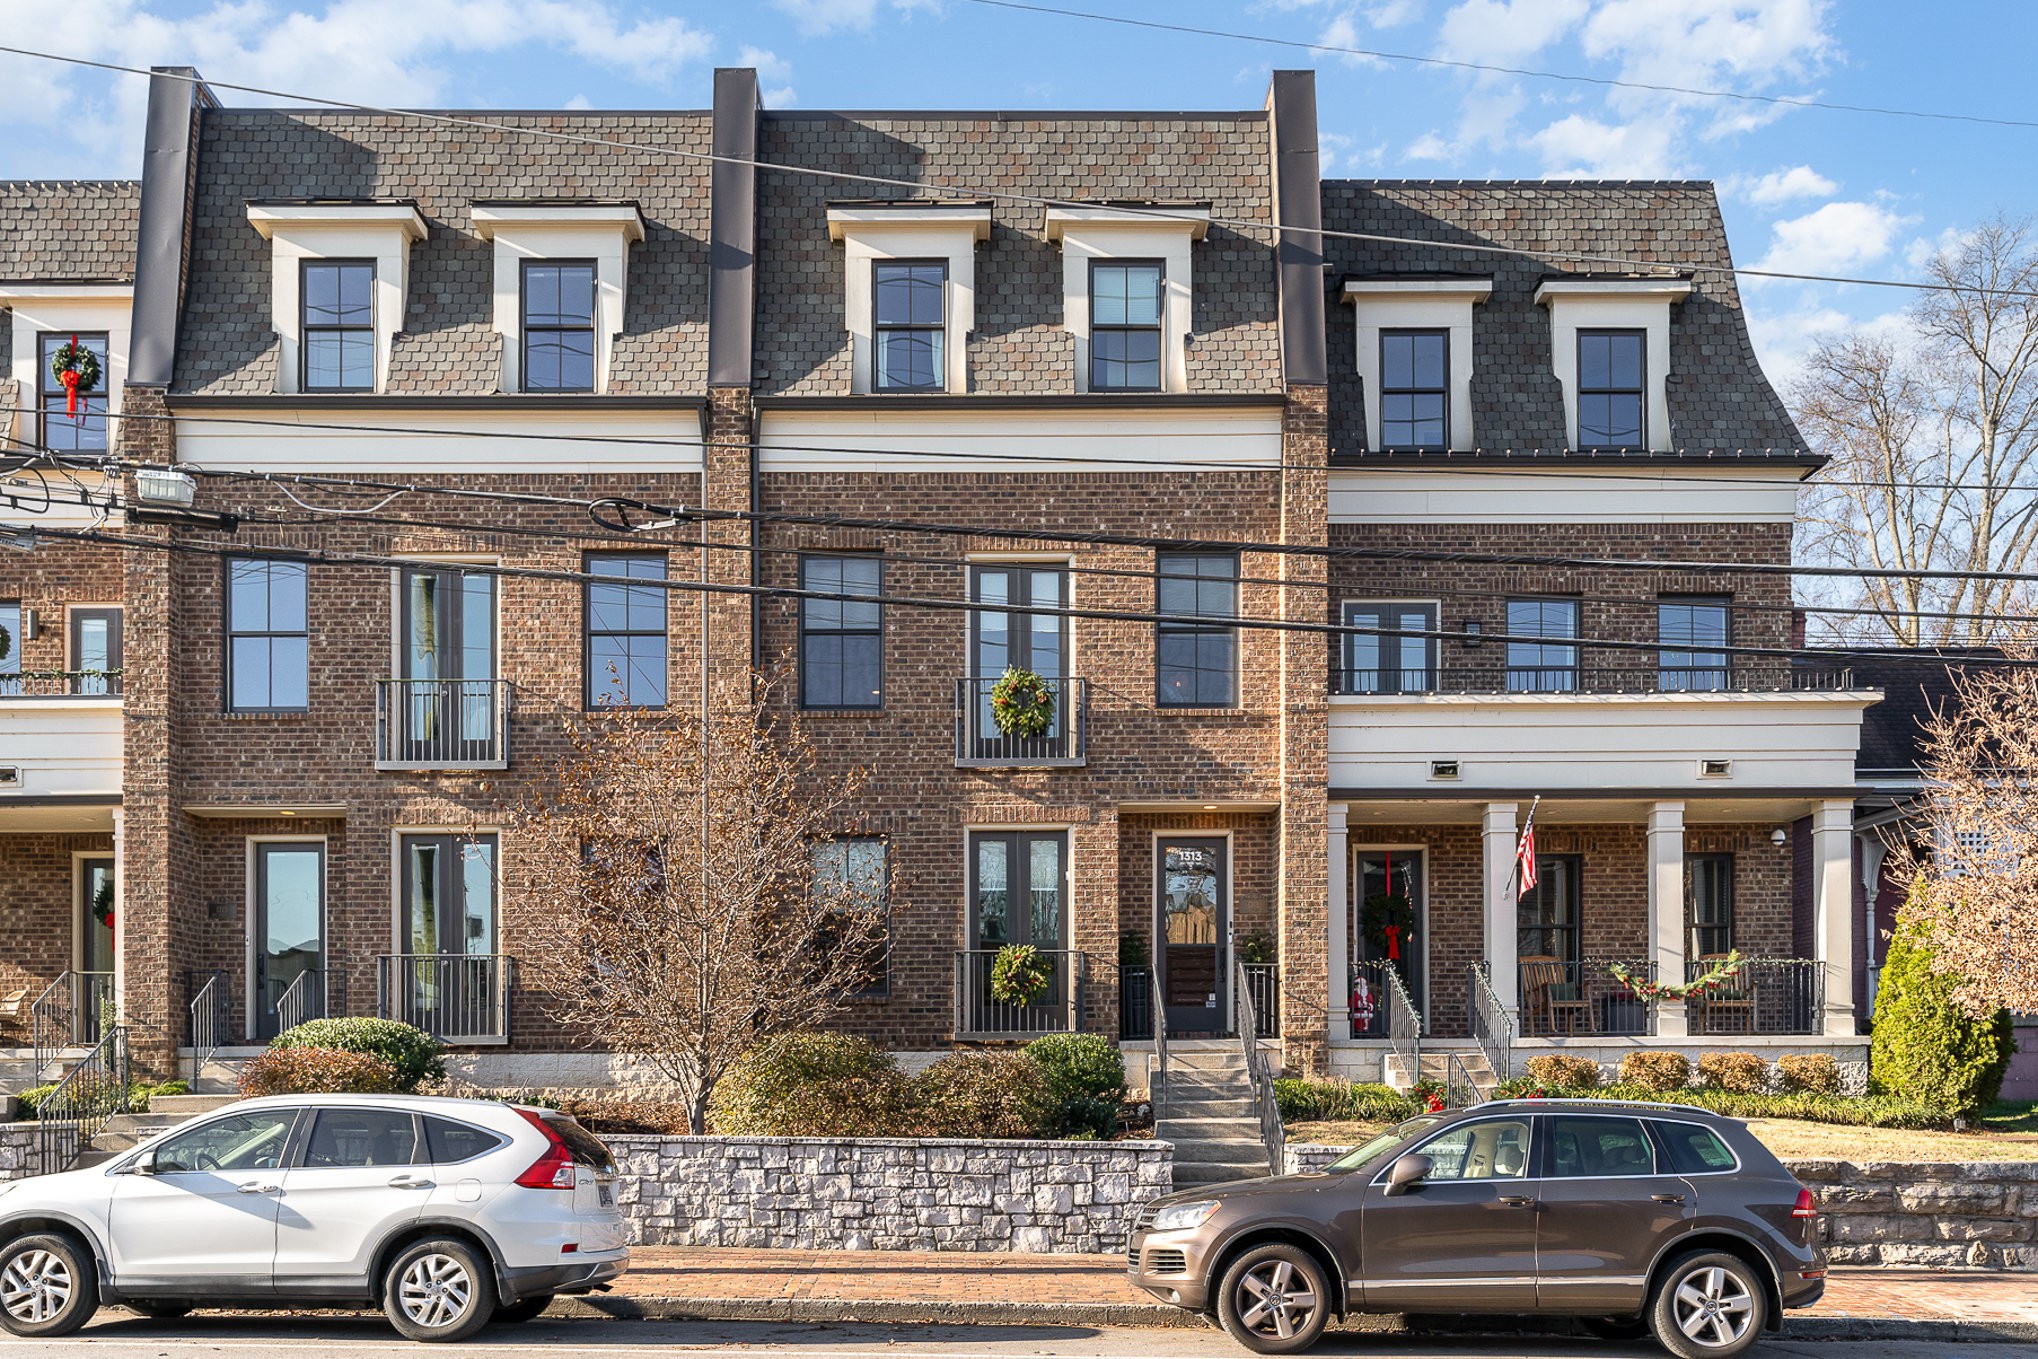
[1323,179,1804,458]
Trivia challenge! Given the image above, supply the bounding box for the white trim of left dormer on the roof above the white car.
[247,204,430,393]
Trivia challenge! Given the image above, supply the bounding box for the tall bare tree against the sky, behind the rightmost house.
[1789,218,2038,646]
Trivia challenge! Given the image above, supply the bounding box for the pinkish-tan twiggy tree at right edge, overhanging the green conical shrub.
[1883,642,2038,1017]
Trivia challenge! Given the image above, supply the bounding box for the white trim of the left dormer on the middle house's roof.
[827,202,990,395]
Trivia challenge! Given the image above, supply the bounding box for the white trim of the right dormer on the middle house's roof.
[1048,206,1211,391]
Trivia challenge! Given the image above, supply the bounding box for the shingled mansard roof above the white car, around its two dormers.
[177,108,709,395]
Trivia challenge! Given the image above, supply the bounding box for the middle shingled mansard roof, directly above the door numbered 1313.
[756,112,1280,395]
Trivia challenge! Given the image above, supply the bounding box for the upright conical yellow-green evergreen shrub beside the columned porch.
[1869,925,2016,1117]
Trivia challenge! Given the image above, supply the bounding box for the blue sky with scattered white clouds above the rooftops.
[0,0,2038,379]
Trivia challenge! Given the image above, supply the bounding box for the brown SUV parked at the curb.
[1127,1100,1826,1359]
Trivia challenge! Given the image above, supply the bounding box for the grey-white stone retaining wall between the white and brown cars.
[605,1137,1174,1253]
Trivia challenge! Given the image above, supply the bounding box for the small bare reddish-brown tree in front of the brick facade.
[520,687,887,1133]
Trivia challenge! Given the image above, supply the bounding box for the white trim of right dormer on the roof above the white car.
[469,202,644,393]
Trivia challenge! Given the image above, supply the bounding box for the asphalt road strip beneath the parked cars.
[0,1310,2038,1359]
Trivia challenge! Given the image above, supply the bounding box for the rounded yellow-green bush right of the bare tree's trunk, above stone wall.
[707,1033,913,1137]
